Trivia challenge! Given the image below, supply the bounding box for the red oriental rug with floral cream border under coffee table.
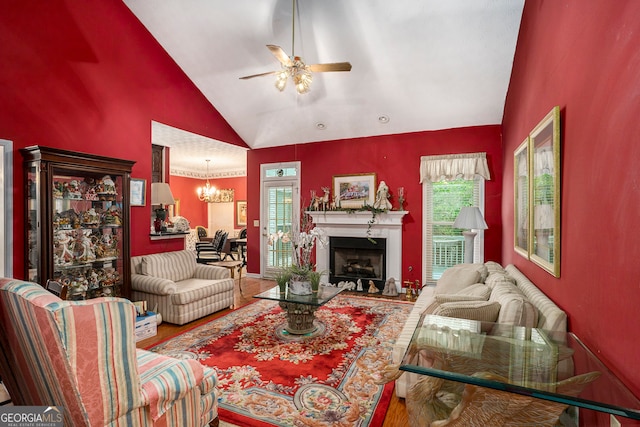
[151,295,412,427]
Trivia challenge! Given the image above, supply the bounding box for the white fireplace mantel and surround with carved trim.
[307,211,409,291]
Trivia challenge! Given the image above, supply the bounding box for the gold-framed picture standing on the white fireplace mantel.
[333,173,377,209]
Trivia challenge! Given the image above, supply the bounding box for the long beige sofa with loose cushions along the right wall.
[393,262,567,397]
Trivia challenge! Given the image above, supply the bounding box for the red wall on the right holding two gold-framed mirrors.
[502,0,640,410]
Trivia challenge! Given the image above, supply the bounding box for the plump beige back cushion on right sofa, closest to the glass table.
[489,283,538,328]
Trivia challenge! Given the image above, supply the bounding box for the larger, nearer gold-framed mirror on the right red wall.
[529,106,560,277]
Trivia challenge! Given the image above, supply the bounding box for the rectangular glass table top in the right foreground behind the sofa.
[400,315,640,420]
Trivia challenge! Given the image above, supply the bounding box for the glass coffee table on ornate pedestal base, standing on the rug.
[254,286,343,336]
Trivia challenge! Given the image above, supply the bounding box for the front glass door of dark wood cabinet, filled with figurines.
[51,168,123,299]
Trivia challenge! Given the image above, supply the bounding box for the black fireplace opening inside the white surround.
[329,237,387,290]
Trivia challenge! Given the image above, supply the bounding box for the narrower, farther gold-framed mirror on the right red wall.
[513,136,530,259]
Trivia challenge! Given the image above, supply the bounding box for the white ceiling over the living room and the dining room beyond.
[124,0,524,177]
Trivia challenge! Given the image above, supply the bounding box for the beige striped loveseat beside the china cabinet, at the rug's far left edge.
[131,250,234,325]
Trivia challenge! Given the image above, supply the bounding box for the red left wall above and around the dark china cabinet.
[0,0,246,277]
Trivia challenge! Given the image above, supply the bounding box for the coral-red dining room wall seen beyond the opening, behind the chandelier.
[170,175,247,229]
